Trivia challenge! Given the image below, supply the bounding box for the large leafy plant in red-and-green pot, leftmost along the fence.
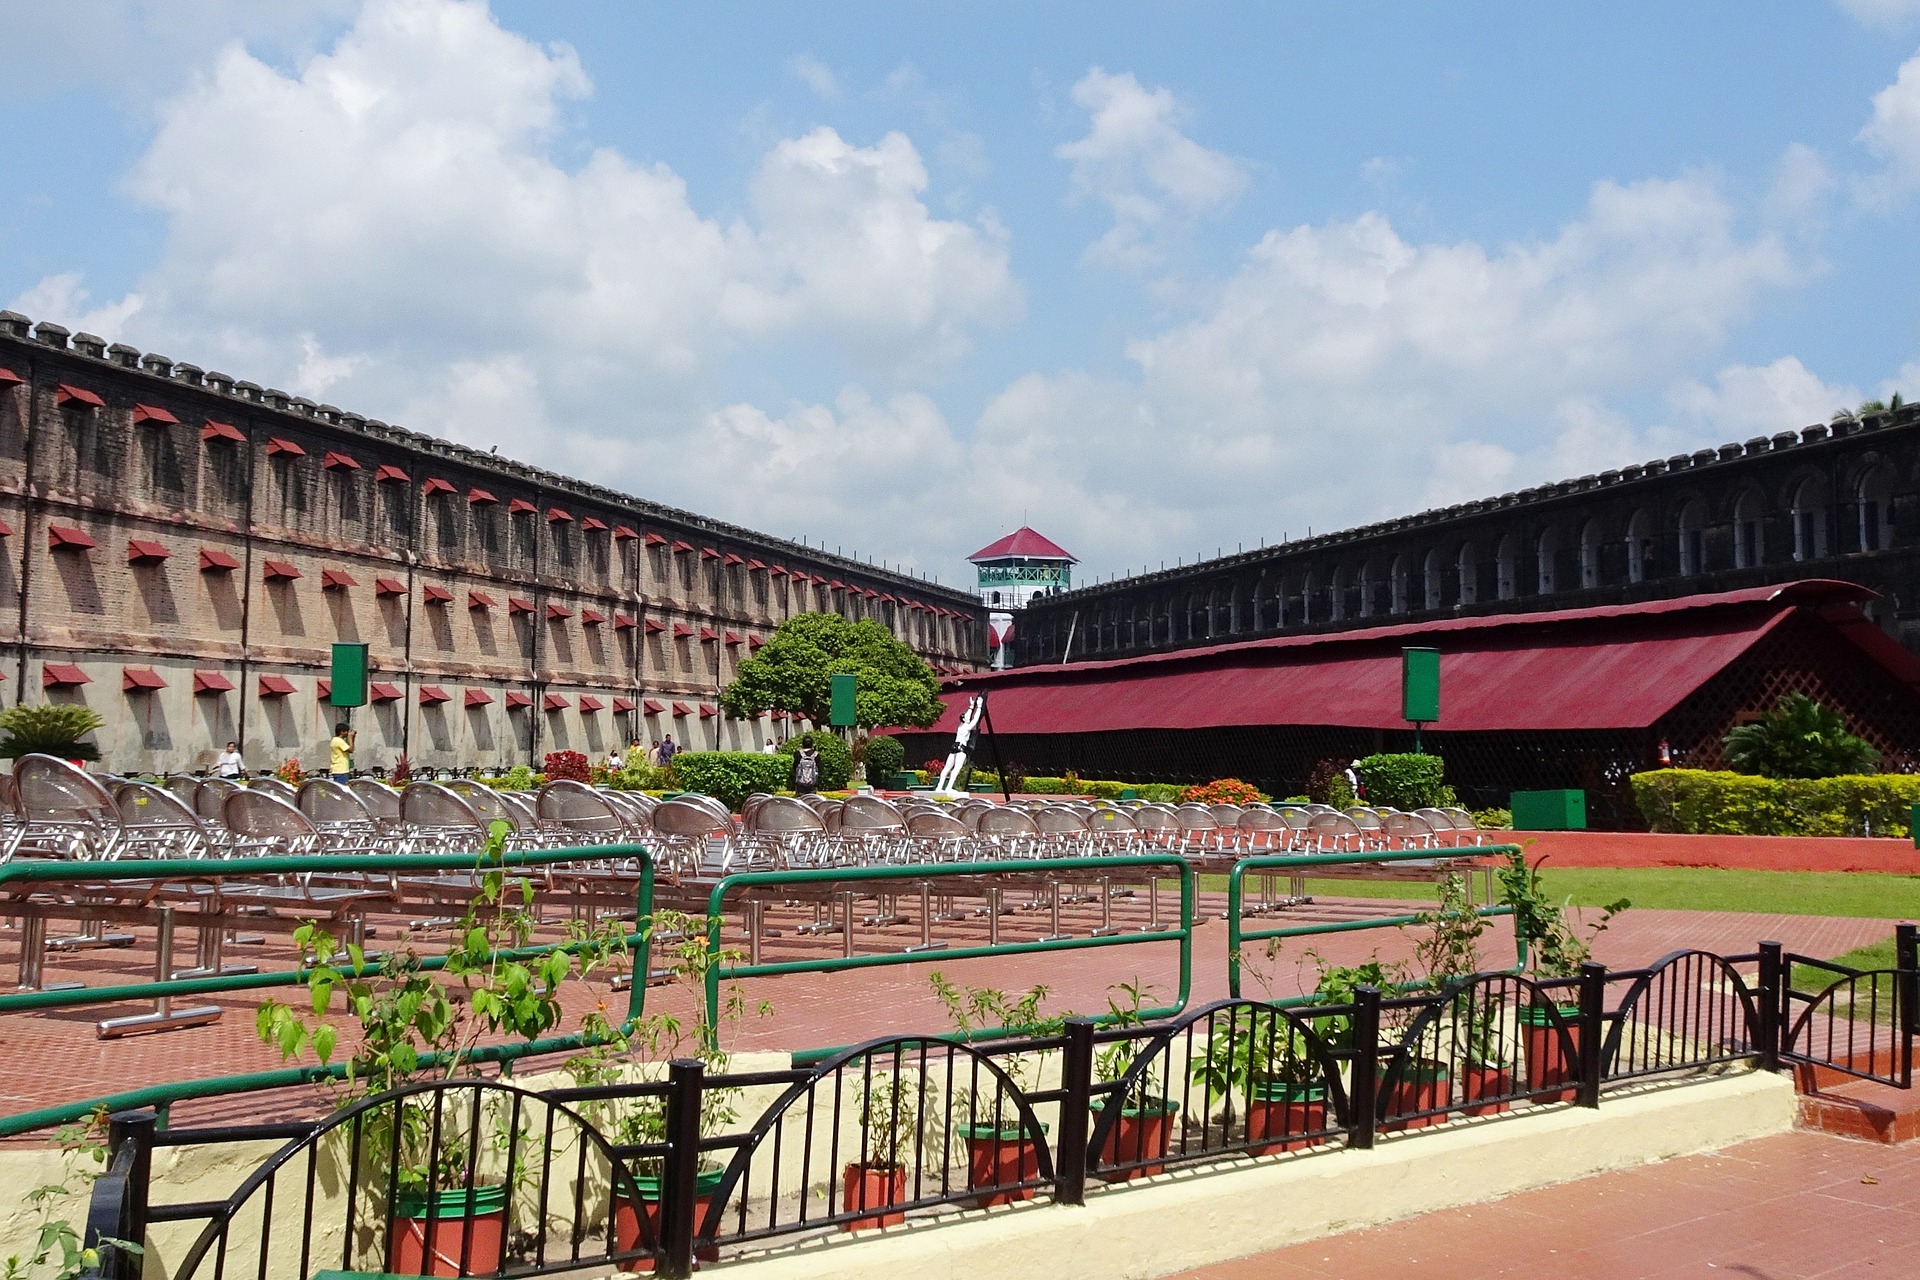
[255,821,624,1276]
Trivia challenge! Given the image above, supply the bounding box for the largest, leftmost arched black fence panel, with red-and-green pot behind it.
[171,1080,662,1280]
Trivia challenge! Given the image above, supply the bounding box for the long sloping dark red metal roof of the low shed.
[933,581,1889,733]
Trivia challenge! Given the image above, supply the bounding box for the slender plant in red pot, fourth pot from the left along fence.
[927,971,1068,1209]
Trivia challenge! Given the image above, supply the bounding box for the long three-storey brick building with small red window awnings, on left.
[0,311,987,771]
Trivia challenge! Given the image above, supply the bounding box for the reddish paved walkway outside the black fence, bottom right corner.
[1177,1132,1920,1280]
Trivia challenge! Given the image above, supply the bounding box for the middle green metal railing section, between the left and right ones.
[707,854,1194,1038]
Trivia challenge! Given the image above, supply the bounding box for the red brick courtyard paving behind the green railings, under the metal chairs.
[0,894,1891,1119]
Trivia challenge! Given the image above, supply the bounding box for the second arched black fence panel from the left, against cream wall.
[693,1036,1066,1257]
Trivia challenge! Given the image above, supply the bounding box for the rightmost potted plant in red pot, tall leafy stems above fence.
[1498,850,1632,1102]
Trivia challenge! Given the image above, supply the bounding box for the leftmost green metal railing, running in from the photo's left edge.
[0,844,653,1138]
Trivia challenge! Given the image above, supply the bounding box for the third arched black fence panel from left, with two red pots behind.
[1087,1000,1354,1182]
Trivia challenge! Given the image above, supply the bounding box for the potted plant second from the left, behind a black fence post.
[564,910,770,1272]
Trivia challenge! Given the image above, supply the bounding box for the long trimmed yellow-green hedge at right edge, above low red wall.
[1632,770,1920,837]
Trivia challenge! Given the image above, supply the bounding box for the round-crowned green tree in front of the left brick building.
[720,614,941,729]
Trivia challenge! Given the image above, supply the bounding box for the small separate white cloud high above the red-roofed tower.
[1054,67,1246,267]
